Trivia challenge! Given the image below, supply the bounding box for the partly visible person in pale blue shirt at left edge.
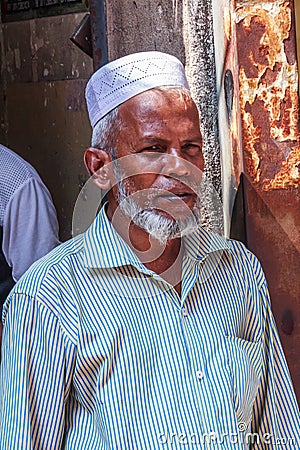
[0,144,59,343]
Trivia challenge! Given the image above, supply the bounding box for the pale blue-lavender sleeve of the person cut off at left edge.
[2,178,59,281]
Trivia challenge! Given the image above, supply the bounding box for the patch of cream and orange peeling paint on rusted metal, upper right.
[235,1,300,190]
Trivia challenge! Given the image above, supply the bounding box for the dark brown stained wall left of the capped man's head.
[0,13,92,240]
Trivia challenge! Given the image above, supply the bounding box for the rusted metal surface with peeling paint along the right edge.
[235,0,300,399]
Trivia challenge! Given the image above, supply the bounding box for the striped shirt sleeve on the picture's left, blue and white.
[0,294,75,450]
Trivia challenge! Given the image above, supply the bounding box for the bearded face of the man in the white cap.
[110,89,203,240]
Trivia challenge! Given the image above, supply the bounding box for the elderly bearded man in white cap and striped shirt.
[0,52,299,450]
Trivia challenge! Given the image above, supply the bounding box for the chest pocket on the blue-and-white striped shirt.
[225,336,262,431]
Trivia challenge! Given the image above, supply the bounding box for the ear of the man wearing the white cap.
[84,147,111,189]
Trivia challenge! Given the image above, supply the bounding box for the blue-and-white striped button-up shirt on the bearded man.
[0,209,300,450]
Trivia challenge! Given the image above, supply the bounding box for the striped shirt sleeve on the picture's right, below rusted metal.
[251,262,300,450]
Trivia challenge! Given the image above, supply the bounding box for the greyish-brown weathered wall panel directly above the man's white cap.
[106,0,185,63]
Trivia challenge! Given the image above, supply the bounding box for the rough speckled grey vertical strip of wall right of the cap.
[183,0,224,234]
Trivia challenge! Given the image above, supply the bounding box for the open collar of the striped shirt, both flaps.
[84,205,232,273]
